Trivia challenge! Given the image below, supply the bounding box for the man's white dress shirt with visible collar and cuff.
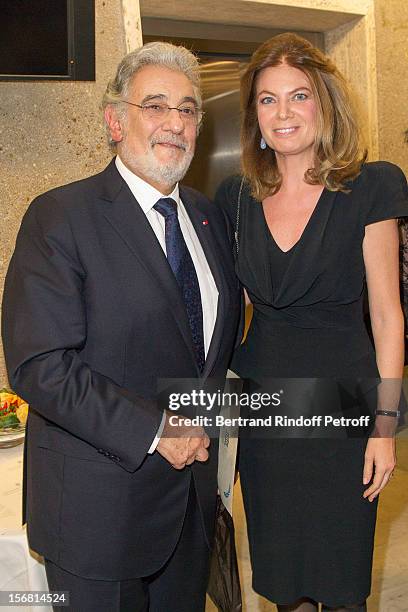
[115,155,218,454]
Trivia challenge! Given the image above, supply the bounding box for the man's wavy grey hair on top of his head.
[102,41,202,149]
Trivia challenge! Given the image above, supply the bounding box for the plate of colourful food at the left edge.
[0,388,28,448]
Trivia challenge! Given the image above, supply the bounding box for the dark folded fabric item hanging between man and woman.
[207,496,242,612]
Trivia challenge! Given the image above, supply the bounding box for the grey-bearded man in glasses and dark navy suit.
[3,43,240,612]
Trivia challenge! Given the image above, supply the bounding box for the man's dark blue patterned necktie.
[153,198,205,372]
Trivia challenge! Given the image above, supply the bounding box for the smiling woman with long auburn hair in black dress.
[216,34,408,611]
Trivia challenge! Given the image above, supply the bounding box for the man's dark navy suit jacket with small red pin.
[2,161,240,580]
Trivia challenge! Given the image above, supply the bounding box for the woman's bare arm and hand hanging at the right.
[363,219,404,502]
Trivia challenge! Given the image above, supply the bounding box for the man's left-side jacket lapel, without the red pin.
[102,161,198,373]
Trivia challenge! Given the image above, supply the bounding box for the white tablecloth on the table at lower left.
[0,444,52,612]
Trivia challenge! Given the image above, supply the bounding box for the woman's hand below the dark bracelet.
[363,438,396,502]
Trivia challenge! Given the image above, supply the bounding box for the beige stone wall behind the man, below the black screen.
[0,0,131,387]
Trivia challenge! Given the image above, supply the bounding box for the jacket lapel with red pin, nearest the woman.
[180,186,227,378]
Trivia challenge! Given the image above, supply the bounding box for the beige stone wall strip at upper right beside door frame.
[375,0,408,176]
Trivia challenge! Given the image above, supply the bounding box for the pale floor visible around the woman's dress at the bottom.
[206,429,408,612]
